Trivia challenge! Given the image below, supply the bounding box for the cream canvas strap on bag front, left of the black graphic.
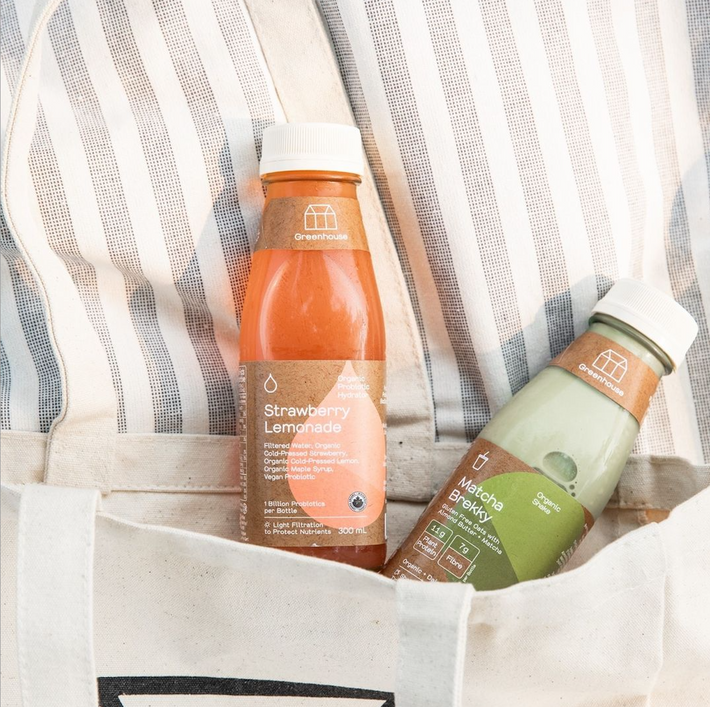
[17,485,100,707]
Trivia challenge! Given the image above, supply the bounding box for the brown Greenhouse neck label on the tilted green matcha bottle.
[550,331,660,425]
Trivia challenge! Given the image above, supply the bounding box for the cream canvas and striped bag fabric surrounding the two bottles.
[0,0,710,707]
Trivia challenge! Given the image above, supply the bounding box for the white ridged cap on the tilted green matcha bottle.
[592,278,698,368]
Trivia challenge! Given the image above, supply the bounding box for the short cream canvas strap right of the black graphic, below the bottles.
[395,580,473,707]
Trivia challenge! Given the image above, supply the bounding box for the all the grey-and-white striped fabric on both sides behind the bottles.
[0,0,710,472]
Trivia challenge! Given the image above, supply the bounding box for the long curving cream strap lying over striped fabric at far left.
[0,0,119,492]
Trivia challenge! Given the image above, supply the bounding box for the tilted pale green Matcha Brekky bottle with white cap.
[384,280,698,590]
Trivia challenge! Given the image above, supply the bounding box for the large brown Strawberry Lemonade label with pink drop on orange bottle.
[239,361,386,547]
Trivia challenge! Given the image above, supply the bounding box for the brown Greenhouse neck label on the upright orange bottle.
[254,196,369,250]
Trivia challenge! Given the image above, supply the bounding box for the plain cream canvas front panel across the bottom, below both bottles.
[3,478,710,707]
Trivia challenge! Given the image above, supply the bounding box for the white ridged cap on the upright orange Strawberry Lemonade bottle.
[259,123,364,176]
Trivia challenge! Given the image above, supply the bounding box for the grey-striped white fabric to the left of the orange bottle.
[2,0,283,435]
